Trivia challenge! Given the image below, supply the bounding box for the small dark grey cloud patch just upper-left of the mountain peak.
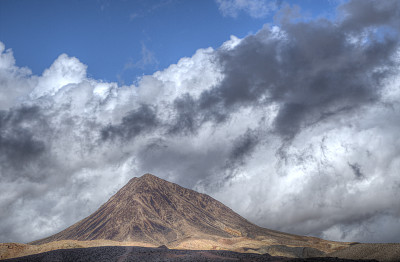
[101,104,158,140]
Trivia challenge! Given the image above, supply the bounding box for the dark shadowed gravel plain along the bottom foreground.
[2,246,376,262]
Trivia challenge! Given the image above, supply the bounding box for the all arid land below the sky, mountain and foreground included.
[0,174,400,261]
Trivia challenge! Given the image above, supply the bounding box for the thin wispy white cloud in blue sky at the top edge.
[216,0,279,18]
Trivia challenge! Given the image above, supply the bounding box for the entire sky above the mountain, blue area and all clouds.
[0,0,400,243]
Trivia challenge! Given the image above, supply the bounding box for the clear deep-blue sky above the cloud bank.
[0,0,336,84]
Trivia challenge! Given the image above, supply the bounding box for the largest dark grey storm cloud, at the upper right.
[186,1,400,138]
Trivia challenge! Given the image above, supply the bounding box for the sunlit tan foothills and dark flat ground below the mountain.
[0,234,400,261]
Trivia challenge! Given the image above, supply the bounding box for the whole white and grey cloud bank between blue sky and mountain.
[0,0,400,242]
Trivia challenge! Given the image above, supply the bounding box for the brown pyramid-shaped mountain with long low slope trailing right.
[30,174,349,252]
